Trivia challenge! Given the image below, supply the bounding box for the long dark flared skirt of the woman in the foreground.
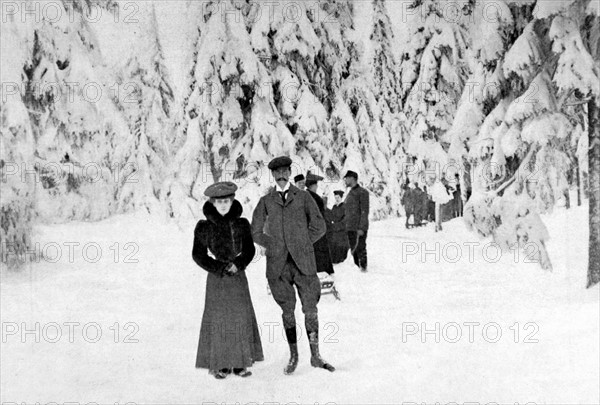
[196,271,264,370]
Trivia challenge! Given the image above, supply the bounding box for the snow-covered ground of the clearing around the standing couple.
[0,208,600,404]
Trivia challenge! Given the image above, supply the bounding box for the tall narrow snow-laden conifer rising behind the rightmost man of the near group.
[331,1,403,218]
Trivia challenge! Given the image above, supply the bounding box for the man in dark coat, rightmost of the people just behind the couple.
[344,170,369,272]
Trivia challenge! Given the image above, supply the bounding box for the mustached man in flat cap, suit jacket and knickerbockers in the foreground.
[252,156,335,374]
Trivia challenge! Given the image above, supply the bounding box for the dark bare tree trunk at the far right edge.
[587,97,600,288]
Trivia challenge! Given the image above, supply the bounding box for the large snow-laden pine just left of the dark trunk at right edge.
[465,2,597,269]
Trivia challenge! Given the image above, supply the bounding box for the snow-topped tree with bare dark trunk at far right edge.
[536,0,600,288]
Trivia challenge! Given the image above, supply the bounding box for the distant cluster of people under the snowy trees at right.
[401,174,463,228]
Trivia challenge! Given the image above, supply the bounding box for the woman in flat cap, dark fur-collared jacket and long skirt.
[192,182,264,379]
